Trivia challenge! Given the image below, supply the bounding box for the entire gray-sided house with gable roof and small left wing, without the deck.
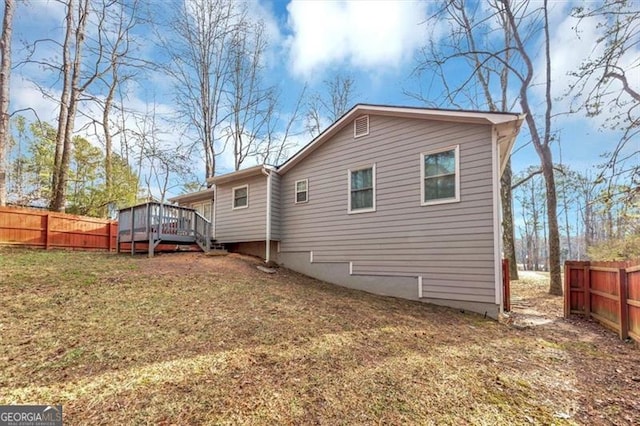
[172,105,523,317]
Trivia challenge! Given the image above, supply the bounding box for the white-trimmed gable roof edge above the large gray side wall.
[277,104,524,173]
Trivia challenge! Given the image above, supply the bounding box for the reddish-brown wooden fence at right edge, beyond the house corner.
[564,261,640,342]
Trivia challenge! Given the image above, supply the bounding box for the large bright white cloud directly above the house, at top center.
[287,0,427,76]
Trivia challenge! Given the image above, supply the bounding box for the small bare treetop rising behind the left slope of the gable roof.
[306,73,355,137]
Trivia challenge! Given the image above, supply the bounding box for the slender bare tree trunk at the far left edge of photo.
[0,0,15,206]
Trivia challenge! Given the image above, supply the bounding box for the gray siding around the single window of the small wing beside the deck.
[215,175,267,243]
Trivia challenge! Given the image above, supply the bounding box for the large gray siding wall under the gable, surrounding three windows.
[280,115,496,303]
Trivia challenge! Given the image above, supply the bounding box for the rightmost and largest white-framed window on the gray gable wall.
[420,145,460,206]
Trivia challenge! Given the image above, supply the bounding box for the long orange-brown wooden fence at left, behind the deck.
[0,207,118,251]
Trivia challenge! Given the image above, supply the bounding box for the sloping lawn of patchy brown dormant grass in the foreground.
[0,249,640,425]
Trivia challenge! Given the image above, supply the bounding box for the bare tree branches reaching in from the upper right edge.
[570,0,640,193]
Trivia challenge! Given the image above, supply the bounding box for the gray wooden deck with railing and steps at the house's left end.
[117,202,211,257]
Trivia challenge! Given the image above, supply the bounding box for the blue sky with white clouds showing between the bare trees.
[5,0,640,199]
